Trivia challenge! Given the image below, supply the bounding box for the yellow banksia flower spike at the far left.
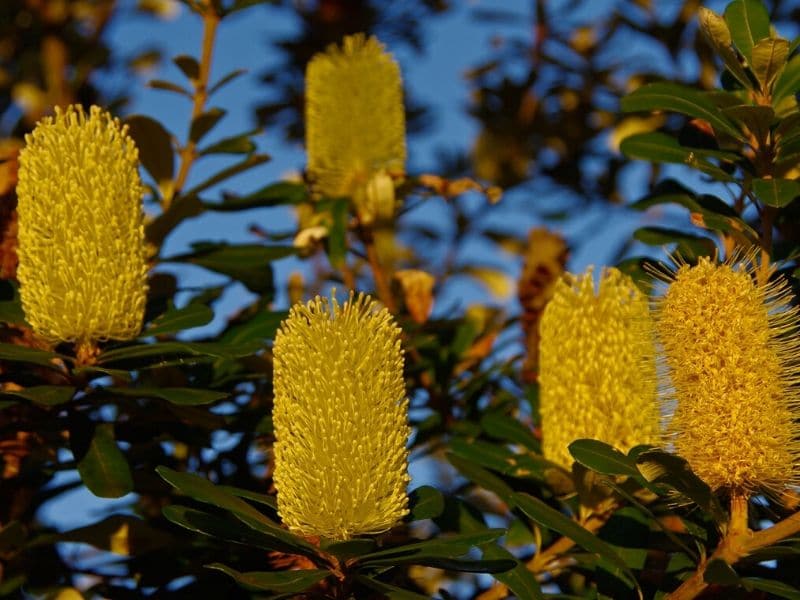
[17,106,147,346]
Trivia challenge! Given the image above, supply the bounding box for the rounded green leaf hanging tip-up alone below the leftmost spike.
[76,423,133,498]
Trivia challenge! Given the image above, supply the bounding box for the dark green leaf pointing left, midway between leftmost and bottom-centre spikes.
[164,243,297,294]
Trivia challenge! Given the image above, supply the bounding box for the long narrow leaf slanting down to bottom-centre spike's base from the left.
[156,466,318,558]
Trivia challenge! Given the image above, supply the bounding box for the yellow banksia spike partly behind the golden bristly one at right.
[539,267,661,468]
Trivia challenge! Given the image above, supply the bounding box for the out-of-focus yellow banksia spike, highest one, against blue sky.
[306,34,406,223]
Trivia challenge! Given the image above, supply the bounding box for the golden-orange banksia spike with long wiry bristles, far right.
[656,258,800,492]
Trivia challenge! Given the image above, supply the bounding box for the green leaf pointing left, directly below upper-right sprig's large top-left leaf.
[620,131,738,182]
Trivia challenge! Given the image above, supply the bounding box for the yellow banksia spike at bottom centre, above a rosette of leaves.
[273,293,410,540]
